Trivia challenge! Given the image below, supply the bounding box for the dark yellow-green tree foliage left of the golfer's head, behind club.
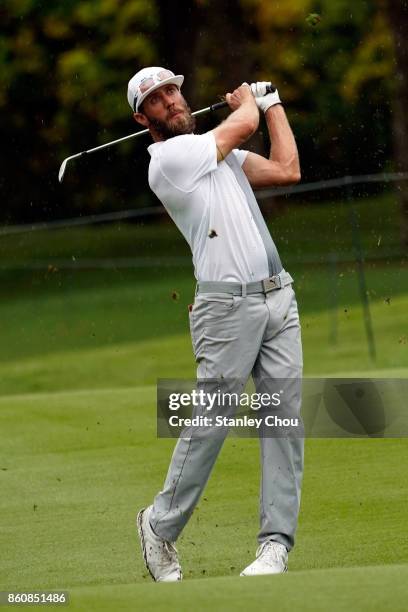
[0,0,158,220]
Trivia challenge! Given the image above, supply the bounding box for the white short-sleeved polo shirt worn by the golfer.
[148,132,269,283]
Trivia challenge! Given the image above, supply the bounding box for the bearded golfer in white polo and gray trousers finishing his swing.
[128,67,303,582]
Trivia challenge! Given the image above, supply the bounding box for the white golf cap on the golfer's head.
[128,66,184,113]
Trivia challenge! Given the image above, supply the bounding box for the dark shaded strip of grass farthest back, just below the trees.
[0,190,400,264]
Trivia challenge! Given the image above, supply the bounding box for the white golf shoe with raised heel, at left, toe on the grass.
[137,506,183,582]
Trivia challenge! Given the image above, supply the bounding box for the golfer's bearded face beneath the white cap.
[134,84,195,140]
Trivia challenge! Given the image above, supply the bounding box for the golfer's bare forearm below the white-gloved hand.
[265,104,300,175]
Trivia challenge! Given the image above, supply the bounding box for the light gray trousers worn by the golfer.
[150,274,303,550]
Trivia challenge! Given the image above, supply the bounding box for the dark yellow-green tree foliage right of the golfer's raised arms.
[252,0,392,180]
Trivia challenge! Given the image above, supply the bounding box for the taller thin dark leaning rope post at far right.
[344,176,376,361]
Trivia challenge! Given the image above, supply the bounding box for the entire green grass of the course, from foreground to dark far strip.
[0,196,408,612]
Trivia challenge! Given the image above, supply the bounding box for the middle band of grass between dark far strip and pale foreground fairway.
[0,266,408,394]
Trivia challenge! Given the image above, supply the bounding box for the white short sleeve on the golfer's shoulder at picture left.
[155,132,217,191]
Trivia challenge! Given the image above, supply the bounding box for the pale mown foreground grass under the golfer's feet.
[0,387,408,610]
